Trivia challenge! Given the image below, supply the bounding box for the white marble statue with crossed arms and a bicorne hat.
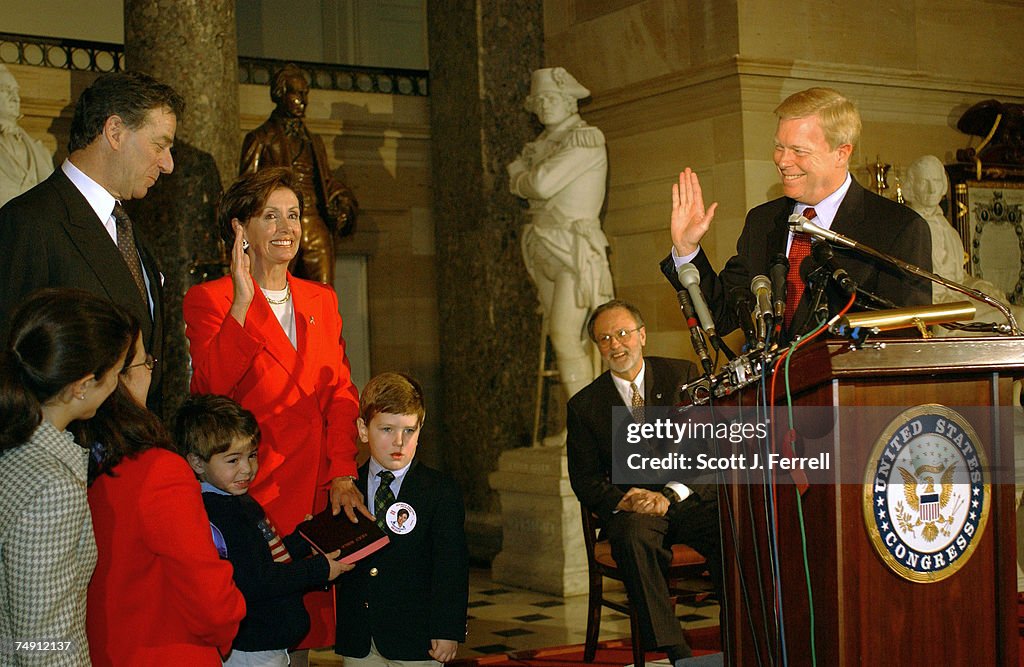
[508,68,613,440]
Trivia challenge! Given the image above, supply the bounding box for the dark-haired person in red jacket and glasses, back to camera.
[82,336,245,667]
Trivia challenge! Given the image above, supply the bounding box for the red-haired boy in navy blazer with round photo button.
[335,373,469,667]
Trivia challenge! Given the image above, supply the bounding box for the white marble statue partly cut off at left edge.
[0,65,53,206]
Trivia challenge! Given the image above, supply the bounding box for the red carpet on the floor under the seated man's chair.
[449,625,722,667]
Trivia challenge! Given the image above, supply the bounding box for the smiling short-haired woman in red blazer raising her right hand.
[184,168,372,648]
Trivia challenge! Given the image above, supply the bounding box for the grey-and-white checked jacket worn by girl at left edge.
[0,420,96,665]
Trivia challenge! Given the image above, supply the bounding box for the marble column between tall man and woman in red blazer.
[125,0,242,416]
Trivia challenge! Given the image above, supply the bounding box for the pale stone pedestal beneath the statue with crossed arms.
[488,447,589,596]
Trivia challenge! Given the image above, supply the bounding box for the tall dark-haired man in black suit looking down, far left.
[0,72,184,405]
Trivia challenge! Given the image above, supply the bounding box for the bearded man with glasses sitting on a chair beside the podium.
[566,299,721,664]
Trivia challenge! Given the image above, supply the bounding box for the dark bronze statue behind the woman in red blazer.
[239,64,358,285]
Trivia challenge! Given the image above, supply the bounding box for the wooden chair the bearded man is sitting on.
[580,504,707,667]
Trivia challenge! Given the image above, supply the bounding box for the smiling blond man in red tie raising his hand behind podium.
[662,88,932,334]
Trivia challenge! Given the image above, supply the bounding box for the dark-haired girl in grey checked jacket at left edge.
[0,289,138,665]
